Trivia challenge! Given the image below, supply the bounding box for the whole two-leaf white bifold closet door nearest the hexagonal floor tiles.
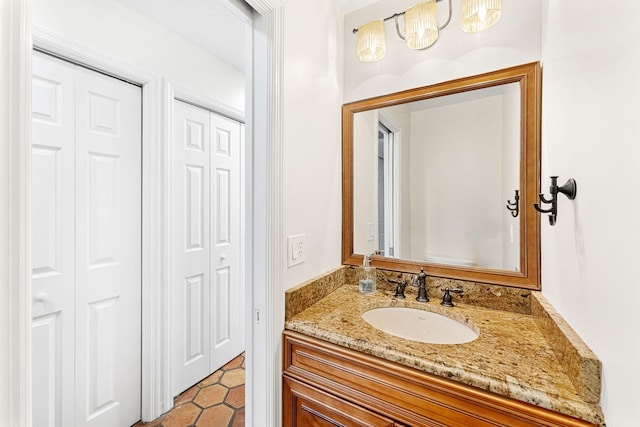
[171,100,244,394]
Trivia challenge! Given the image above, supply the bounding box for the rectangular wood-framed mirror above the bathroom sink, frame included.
[342,62,541,289]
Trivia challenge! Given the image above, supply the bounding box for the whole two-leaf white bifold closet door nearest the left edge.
[32,52,142,427]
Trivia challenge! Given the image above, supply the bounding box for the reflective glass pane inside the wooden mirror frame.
[353,83,521,271]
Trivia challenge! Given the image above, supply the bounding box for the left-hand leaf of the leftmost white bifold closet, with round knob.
[31,52,75,427]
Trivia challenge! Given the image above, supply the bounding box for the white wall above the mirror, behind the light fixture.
[344,0,541,102]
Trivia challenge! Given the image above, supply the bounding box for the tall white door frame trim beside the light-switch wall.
[245,0,286,427]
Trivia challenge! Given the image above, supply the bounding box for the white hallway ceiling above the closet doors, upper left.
[117,0,245,72]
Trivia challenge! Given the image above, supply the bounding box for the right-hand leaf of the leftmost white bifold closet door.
[75,63,142,427]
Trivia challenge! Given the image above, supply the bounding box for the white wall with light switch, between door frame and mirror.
[282,0,342,288]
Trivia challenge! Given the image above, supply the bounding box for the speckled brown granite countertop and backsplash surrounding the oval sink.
[285,267,604,425]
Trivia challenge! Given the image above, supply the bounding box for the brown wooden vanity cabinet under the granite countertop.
[283,331,592,427]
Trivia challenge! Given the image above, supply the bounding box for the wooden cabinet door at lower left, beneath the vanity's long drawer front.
[283,377,396,427]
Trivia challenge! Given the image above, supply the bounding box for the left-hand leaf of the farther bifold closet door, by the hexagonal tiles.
[171,101,211,395]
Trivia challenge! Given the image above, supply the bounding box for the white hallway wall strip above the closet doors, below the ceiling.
[32,0,245,112]
